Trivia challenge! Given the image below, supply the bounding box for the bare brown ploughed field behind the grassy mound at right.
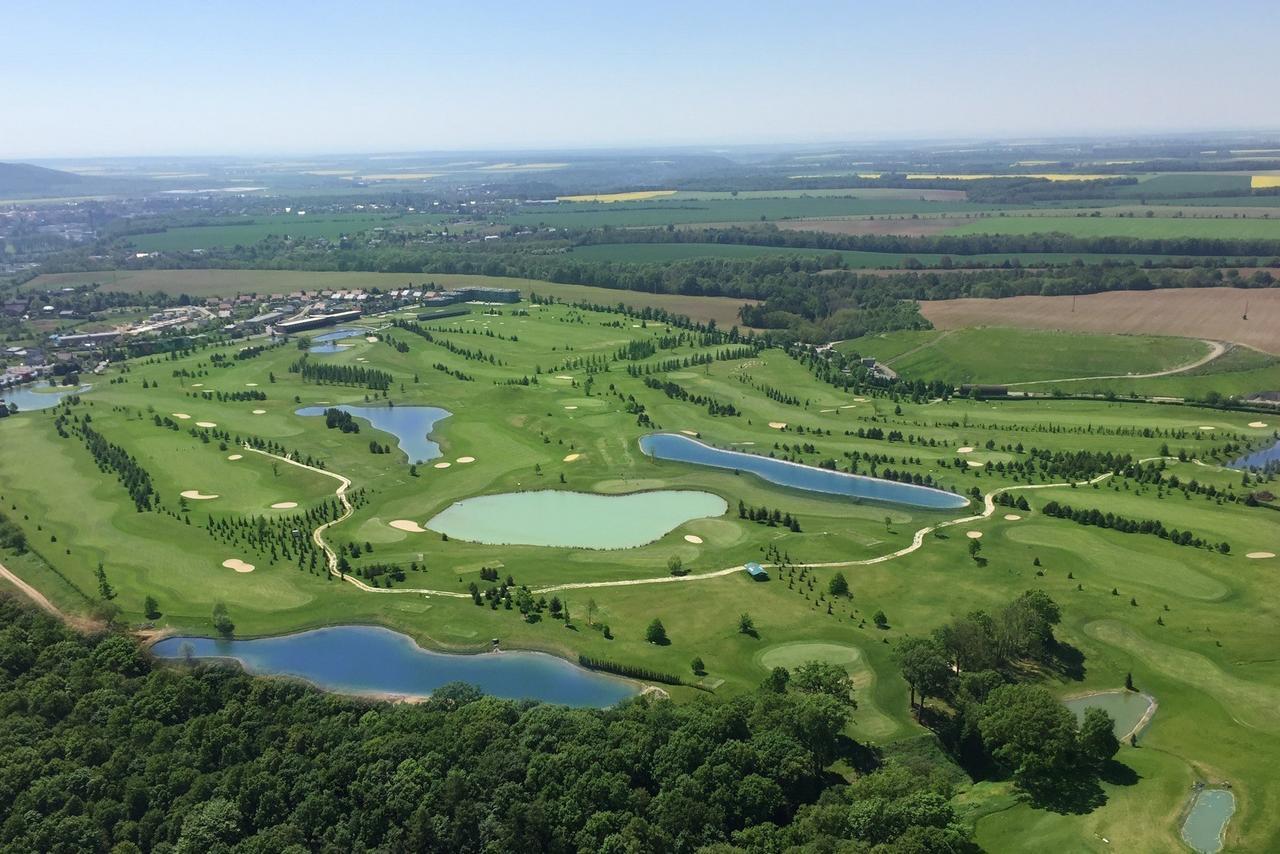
[920,288,1280,355]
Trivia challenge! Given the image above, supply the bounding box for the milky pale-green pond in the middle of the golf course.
[426,489,728,549]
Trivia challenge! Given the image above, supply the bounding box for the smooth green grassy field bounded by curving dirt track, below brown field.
[840,326,1210,384]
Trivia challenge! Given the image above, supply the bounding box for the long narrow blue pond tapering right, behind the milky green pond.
[640,433,969,510]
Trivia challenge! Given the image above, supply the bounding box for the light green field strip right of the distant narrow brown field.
[945,215,1280,239]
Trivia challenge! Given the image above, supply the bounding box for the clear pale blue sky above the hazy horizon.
[0,0,1280,157]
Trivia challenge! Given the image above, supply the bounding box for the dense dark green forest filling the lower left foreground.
[0,598,973,854]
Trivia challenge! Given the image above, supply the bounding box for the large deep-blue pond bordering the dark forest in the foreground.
[151,626,640,708]
